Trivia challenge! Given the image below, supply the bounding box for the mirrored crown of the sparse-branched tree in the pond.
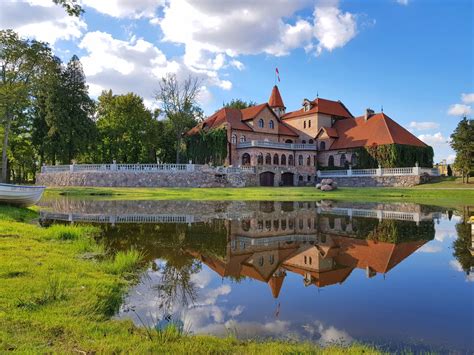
[156,260,202,313]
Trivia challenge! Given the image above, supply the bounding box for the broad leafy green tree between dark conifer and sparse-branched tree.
[97,90,158,163]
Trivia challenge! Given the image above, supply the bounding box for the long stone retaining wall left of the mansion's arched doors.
[36,168,258,187]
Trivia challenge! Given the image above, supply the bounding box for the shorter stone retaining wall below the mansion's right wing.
[318,175,439,187]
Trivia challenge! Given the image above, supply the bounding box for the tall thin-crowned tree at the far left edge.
[0,30,51,181]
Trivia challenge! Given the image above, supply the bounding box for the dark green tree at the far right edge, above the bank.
[451,117,474,183]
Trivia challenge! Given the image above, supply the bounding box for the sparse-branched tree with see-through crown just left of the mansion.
[156,74,202,164]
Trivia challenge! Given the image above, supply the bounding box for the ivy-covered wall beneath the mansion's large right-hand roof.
[355,144,434,169]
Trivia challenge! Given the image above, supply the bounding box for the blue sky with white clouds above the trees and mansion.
[0,0,474,162]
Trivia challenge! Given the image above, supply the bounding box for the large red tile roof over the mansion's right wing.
[329,113,426,150]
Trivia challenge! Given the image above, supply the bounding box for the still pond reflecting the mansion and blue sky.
[40,198,474,353]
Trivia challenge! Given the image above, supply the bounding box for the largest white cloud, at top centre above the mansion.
[156,0,357,70]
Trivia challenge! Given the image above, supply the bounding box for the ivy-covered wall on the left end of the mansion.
[186,128,228,165]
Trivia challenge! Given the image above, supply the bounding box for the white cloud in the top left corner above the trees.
[0,0,87,45]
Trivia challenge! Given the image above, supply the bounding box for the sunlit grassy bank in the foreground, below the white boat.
[0,206,376,353]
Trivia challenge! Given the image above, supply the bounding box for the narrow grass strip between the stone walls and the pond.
[46,181,474,207]
